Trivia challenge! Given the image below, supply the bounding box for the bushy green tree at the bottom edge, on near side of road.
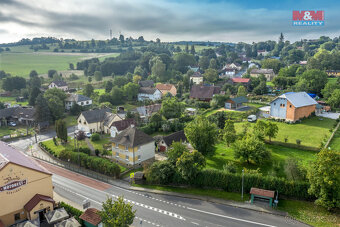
[99,197,136,227]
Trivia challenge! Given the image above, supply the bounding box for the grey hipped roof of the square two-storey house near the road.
[111,127,154,147]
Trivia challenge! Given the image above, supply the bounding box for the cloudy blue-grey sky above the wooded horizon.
[0,0,340,43]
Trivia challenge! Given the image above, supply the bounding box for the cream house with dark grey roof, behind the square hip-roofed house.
[77,109,123,133]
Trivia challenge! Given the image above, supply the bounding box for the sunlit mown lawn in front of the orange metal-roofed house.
[235,117,335,148]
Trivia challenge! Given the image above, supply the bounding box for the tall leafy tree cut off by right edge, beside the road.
[307,149,340,210]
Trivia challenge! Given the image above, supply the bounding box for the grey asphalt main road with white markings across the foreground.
[53,171,307,227]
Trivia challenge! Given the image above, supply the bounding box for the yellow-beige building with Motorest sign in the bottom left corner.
[0,142,54,226]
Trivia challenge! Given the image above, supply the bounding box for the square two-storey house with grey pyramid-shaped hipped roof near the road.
[111,126,155,166]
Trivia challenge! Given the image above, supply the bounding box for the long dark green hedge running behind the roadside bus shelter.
[147,169,314,200]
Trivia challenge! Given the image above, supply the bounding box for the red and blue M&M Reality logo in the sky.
[293,10,325,26]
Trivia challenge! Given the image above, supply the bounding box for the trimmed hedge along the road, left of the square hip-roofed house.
[40,143,120,178]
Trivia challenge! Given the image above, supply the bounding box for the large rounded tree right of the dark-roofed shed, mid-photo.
[184,116,218,155]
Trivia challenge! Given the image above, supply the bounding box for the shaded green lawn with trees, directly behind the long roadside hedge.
[206,143,316,177]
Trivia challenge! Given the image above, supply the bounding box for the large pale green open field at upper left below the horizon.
[0,51,118,77]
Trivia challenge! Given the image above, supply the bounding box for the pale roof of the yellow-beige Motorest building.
[0,141,50,174]
